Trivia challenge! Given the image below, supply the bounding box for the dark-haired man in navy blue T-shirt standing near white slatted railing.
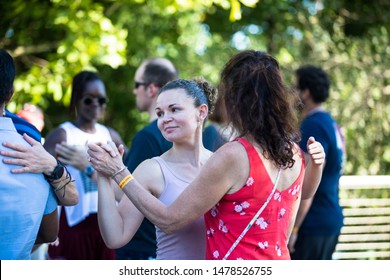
[289,65,344,260]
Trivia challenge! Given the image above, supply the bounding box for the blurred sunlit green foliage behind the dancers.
[0,0,390,174]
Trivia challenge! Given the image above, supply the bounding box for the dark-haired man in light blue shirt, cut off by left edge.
[0,49,58,260]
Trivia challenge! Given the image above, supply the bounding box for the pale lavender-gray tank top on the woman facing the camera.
[153,157,206,260]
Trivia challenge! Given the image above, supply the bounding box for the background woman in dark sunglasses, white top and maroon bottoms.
[44,71,123,260]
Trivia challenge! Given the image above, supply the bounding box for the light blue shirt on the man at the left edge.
[0,117,57,260]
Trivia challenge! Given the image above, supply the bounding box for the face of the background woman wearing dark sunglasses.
[77,80,107,122]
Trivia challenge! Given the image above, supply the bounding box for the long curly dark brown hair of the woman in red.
[219,50,300,168]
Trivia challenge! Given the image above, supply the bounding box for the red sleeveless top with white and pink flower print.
[204,138,305,260]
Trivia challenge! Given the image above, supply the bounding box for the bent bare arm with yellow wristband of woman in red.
[88,140,244,233]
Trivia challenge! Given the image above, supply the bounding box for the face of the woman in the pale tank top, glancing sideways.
[156,88,207,143]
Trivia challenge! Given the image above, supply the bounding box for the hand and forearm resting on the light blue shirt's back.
[0,134,78,206]
